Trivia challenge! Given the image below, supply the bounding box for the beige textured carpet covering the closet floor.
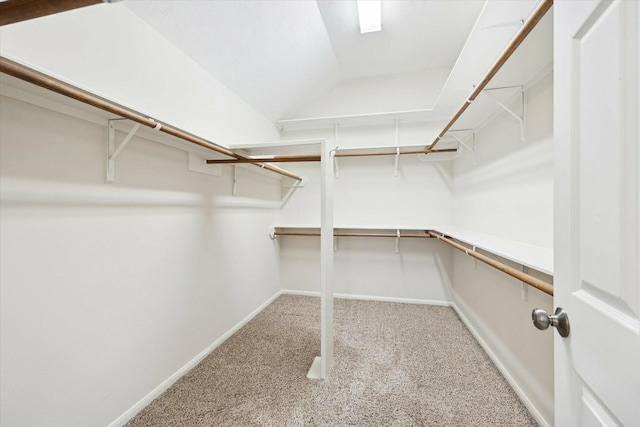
[127,295,537,427]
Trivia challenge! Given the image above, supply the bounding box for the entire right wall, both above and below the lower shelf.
[451,74,553,424]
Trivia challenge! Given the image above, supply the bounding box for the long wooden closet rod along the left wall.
[0,57,302,181]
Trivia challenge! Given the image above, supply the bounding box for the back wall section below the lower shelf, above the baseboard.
[278,236,453,305]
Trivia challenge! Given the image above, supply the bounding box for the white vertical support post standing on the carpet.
[307,139,337,379]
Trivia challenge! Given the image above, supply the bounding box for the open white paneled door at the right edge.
[554,0,640,426]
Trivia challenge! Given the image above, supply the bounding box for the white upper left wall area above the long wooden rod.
[0,3,279,144]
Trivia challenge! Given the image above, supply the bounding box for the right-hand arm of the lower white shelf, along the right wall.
[431,226,553,276]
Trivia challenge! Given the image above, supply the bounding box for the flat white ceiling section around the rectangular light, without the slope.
[318,0,484,78]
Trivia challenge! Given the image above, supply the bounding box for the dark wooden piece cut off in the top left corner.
[0,0,103,26]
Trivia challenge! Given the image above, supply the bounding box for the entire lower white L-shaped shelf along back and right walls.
[273,224,553,276]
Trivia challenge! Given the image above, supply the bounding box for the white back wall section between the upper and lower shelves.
[280,124,453,228]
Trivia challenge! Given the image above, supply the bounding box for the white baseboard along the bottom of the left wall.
[108,291,283,427]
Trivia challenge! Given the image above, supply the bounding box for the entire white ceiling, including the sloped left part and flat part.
[125,0,485,121]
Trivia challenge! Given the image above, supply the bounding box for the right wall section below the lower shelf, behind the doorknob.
[450,250,556,425]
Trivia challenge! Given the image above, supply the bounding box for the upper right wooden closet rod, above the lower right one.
[428,0,553,150]
